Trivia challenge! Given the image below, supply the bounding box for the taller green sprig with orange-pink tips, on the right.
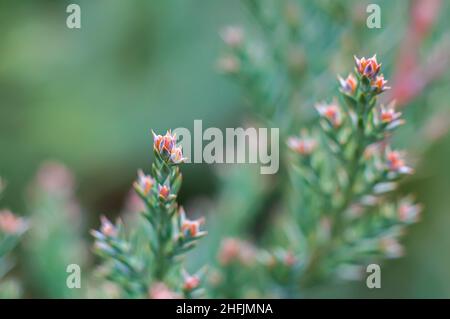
[288,56,420,283]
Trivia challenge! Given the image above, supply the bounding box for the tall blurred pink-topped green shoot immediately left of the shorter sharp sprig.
[24,162,88,298]
